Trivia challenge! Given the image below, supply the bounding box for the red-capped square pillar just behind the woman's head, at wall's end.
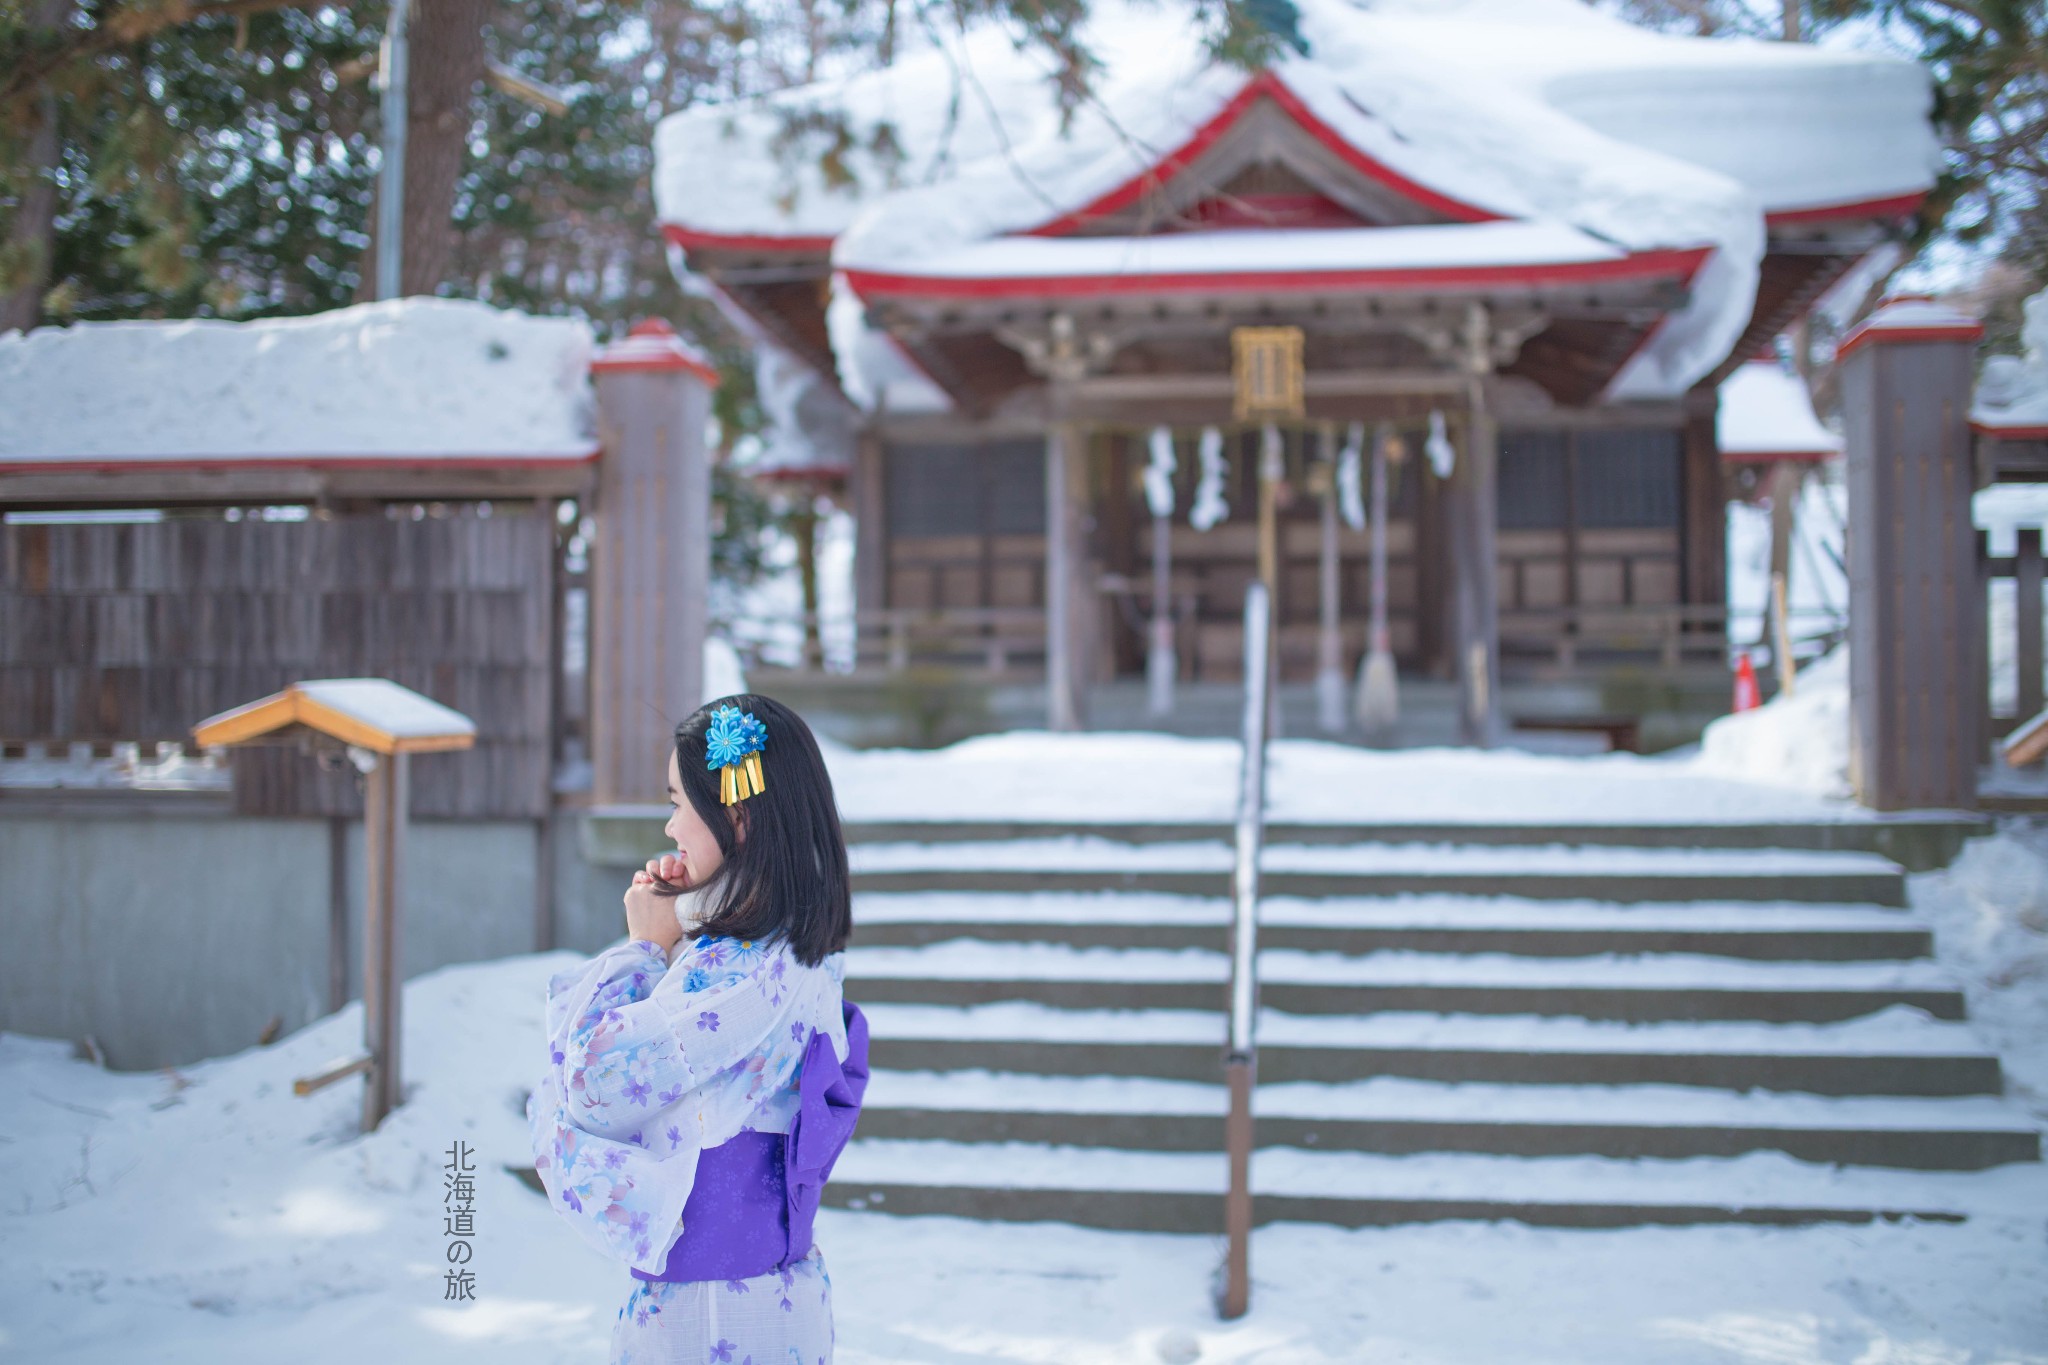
[590,319,719,804]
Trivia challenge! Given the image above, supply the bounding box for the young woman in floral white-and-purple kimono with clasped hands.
[526,696,868,1365]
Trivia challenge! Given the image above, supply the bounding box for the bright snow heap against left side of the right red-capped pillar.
[1692,645,1849,798]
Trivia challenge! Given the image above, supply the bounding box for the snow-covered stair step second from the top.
[850,835,1905,905]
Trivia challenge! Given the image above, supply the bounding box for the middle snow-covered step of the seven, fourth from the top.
[846,939,1964,1021]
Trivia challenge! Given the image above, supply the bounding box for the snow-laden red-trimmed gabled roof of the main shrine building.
[655,0,1939,405]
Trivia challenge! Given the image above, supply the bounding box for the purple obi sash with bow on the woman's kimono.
[633,1001,868,1281]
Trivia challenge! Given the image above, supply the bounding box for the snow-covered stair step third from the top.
[854,890,1933,962]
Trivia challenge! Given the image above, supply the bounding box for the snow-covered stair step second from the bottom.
[843,1070,2040,1171]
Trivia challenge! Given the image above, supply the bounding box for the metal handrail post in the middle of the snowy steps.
[1219,583,1272,1318]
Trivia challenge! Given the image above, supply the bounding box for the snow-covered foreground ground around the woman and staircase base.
[0,821,2048,1365]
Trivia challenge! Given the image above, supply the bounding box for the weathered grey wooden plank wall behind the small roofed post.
[0,503,557,819]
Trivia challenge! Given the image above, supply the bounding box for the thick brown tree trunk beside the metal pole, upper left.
[356,0,489,303]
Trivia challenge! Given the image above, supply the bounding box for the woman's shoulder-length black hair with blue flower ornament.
[676,692,854,966]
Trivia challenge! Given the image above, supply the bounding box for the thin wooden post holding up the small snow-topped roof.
[362,753,412,1132]
